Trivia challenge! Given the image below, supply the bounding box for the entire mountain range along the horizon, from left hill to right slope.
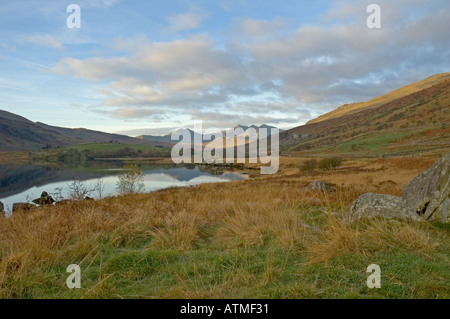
[0,73,450,156]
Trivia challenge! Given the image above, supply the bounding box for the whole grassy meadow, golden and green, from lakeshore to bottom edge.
[0,158,450,298]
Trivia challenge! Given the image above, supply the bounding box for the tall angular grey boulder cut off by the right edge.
[402,154,450,221]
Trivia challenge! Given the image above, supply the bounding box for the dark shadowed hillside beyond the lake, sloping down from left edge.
[0,110,171,151]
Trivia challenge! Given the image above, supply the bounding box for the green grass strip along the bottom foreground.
[8,238,450,299]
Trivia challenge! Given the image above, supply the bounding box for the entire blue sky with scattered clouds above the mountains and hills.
[0,0,450,135]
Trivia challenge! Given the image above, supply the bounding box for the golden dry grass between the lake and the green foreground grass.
[0,158,447,298]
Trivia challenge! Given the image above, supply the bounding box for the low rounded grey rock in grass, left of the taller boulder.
[347,193,420,220]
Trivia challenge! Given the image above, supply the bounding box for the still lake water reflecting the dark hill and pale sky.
[0,163,248,213]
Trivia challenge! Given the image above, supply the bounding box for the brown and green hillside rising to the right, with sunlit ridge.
[280,73,450,156]
